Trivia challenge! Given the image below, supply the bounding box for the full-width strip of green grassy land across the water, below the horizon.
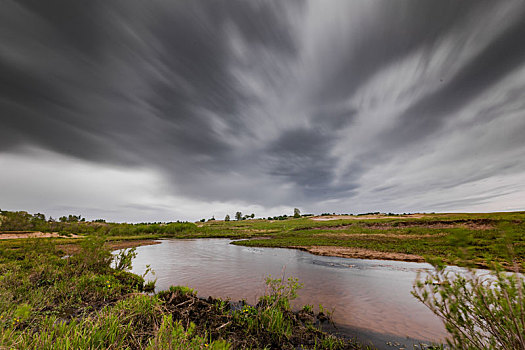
[0,212,525,269]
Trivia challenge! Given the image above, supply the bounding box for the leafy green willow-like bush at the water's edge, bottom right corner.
[412,263,525,350]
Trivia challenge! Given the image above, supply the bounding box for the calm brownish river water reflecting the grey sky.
[129,239,446,349]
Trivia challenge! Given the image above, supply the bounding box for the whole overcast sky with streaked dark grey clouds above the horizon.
[0,0,525,221]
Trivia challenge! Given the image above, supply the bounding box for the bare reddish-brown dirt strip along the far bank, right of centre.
[290,246,425,262]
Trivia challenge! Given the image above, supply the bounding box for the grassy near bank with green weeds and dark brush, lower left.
[0,236,359,349]
